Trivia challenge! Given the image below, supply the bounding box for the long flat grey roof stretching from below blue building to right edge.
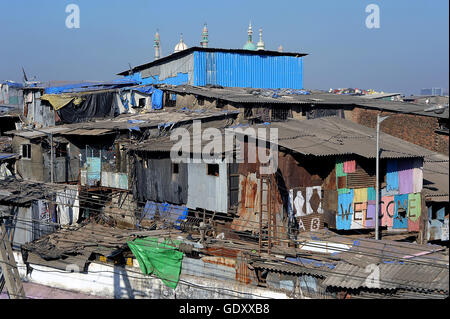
[160,85,449,119]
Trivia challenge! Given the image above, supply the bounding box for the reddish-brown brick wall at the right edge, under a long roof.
[352,107,449,155]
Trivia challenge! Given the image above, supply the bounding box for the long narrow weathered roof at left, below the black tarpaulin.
[5,110,239,139]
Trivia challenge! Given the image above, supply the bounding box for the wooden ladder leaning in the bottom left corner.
[0,219,26,299]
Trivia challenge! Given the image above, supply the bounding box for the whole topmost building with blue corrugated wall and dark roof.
[118,47,306,89]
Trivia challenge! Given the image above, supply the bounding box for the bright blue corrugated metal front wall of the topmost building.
[193,52,303,89]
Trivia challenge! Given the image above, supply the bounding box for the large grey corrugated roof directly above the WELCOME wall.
[244,117,433,158]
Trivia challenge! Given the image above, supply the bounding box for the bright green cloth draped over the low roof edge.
[127,237,183,289]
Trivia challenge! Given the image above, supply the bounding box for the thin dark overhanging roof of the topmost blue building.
[117,47,308,76]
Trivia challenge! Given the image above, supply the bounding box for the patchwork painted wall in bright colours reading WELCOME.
[336,158,423,231]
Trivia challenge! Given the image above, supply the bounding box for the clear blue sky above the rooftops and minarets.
[0,0,449,95]
